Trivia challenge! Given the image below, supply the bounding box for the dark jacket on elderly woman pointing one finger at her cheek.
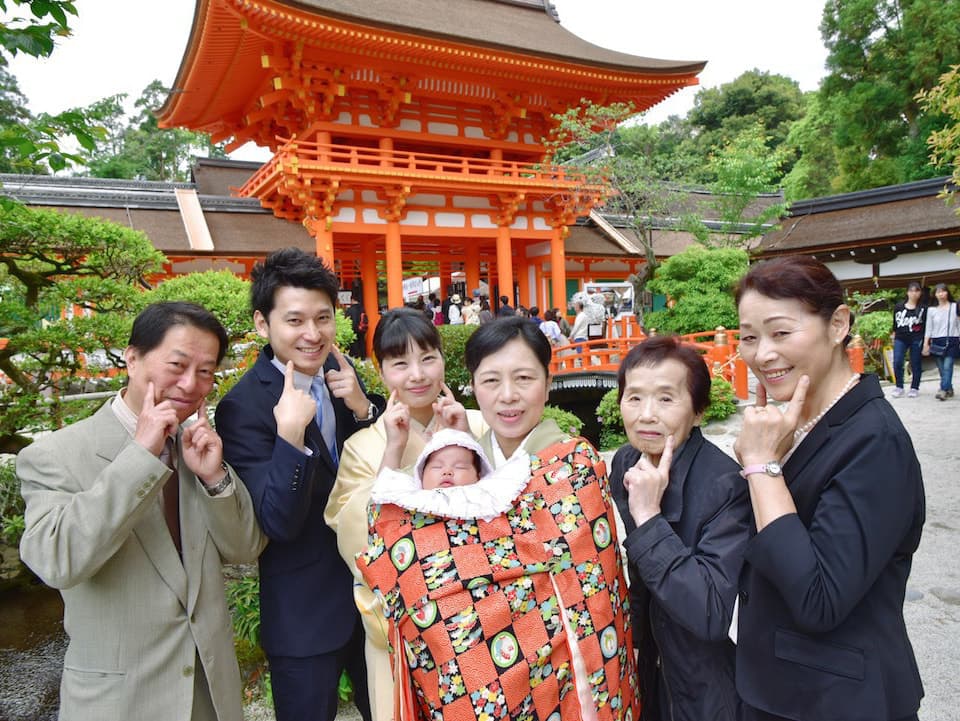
[610,428,750,721]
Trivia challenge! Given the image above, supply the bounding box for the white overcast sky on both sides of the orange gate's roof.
[11,0,826,157]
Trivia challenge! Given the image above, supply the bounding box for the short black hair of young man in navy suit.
[250,248,340,319]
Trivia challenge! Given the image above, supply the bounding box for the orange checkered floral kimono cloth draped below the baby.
[358,439,640,721]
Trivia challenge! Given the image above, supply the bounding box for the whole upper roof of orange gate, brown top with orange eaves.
[157,0,705,135]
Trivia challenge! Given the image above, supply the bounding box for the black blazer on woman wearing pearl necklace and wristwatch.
[737,375,925,721]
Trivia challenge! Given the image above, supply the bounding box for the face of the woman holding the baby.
[473,338,550,458]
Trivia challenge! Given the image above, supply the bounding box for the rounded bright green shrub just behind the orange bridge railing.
[644,246,748,335]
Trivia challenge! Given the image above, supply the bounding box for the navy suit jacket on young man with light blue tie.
[216,345,382,657]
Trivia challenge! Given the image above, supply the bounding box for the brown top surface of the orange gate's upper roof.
[288,0,706,73]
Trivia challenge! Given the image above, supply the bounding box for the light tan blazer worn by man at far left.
[17,402,266,721]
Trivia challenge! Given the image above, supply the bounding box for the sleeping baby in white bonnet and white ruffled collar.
[370,428,530,519]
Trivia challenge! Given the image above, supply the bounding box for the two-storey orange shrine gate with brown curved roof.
[158,0,704,318]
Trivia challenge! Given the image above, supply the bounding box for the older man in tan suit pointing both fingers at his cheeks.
[17,303,266,721]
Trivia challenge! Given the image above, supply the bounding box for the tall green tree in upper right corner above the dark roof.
[820,0,960,191]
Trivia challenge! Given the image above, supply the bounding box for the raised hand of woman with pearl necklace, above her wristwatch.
[733,375,810,466]
